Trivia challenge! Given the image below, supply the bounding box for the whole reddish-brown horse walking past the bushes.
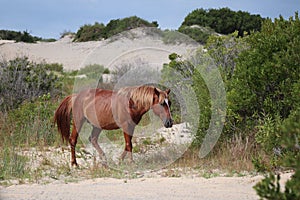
[54,86,173,166]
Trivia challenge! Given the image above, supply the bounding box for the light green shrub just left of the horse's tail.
[4,94,58,146]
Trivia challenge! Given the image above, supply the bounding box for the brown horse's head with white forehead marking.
[151,88,173,128]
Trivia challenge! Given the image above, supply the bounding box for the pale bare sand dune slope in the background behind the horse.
[0,28,199,70]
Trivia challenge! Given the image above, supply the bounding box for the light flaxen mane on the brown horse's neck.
[117,85,154,108]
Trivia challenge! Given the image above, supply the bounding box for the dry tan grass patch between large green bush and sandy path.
[172,135,258,173]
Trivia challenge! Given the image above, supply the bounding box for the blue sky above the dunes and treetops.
[0,0,300,39]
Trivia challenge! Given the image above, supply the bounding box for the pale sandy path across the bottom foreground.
[0,176,272,200]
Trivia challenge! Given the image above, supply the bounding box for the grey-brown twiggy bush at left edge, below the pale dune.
[0,57,62,111]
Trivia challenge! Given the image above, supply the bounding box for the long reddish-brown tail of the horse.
[54,94,76,142]
